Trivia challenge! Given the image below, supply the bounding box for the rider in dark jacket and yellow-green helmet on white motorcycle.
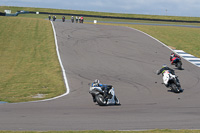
[156,64,175,87]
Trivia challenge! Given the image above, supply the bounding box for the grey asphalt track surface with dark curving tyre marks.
[0,22,200,131]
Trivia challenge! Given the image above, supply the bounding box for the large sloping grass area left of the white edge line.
[0,17,65,102]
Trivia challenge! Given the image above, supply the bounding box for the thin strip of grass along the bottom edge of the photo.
[0,129,200,133]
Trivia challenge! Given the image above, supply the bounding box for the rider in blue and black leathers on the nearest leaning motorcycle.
[92,79,112,102]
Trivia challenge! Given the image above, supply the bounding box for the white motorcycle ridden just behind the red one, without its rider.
[163,70,183,93]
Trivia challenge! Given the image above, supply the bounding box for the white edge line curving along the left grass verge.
[11,21,70,104]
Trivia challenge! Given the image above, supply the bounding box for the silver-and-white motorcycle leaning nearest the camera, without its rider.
[89,86,120,106]
